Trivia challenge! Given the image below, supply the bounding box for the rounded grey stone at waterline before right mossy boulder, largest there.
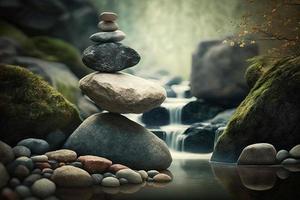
[237,143,277,165]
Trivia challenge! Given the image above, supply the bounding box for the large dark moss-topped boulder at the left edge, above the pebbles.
[0,65,80,144]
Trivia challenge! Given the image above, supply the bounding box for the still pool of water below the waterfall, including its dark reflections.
[57,155,300,200]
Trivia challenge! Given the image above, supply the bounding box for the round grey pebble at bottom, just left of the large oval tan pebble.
[31,178,56,198]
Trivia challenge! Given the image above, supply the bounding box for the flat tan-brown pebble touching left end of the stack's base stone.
[46,149,77,162]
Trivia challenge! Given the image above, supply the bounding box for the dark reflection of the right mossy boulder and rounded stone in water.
[211,164,300,200]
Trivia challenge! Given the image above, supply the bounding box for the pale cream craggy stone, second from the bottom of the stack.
[79,72,166,113]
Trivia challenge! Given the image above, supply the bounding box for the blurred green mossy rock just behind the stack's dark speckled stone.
[32,36,92,78]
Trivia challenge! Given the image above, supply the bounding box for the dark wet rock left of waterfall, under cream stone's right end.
[142,106,170,126]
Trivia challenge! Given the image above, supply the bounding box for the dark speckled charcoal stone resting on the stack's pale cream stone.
[82,42,141,72]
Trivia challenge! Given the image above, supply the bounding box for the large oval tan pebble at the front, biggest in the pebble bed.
[51,166,93,187]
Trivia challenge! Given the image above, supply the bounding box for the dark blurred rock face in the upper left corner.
[0,0,98,49]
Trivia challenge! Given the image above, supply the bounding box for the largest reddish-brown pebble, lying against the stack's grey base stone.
[78,156,112,174]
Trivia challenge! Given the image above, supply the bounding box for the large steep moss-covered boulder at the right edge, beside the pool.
[212,57,300,162]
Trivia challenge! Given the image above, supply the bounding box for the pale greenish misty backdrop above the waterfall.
[93,0,243,79]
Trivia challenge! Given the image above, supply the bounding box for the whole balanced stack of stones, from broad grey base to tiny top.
[65,12,172,169]
